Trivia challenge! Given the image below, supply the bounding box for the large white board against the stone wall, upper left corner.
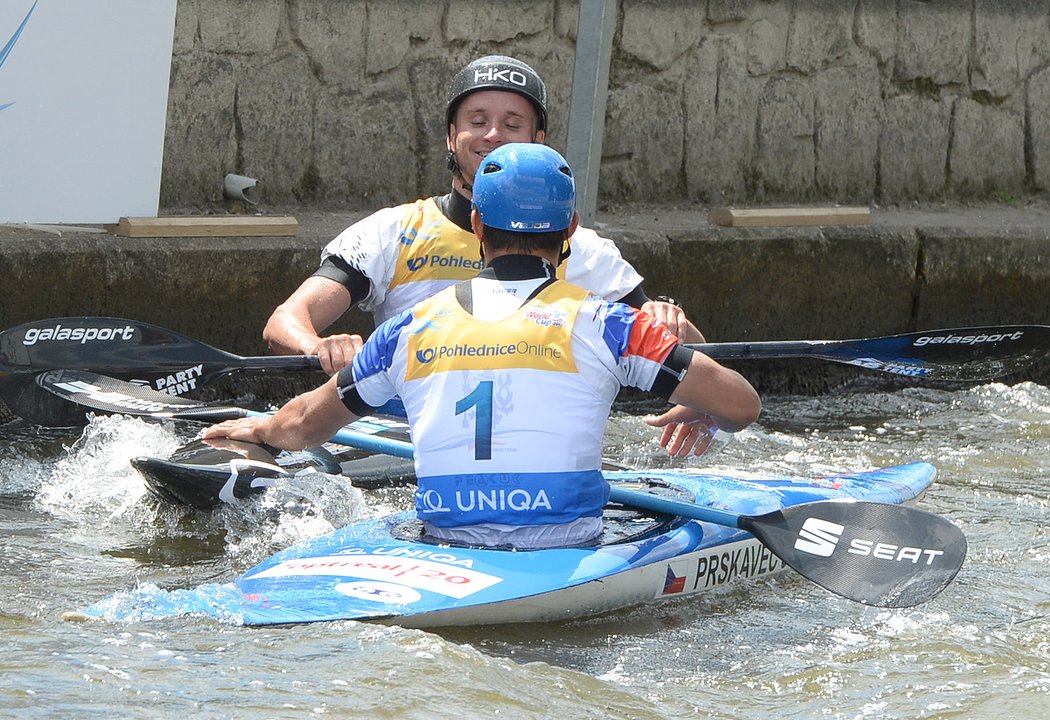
[0,0,175,224]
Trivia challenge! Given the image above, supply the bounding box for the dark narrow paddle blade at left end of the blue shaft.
[36,369,248,422]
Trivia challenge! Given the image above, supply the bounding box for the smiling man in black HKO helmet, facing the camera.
[263,55,704,375]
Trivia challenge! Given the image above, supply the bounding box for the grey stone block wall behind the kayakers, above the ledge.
[162,0,1050,209]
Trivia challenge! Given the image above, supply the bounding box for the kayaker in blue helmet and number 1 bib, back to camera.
[204,143,760,549]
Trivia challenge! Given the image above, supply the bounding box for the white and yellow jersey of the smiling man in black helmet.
[321,197,642,324]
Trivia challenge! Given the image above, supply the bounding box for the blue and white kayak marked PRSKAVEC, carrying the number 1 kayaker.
[76,463,940,628]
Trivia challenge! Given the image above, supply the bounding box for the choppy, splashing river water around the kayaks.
[0,381,1050,720]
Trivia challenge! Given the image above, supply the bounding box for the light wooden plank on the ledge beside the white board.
[106,215,299,237]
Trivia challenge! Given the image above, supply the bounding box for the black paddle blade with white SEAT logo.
[739,501,966,608]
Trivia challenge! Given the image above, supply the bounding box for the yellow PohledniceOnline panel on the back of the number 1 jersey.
[405,282,588,381]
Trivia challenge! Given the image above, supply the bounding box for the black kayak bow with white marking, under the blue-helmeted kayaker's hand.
[131,439,340,510]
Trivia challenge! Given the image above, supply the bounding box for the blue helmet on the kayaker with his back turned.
[474,143,576,233]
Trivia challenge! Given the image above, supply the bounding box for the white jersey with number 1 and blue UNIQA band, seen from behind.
[340,263,676,527]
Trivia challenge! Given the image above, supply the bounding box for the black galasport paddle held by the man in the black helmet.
[6,317,1050,426]
